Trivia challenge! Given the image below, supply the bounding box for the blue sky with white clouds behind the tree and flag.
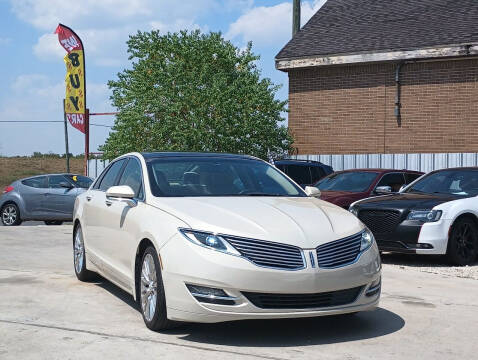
[0,0,325,156]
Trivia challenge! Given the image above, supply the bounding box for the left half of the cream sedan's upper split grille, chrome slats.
[226,237,304,270]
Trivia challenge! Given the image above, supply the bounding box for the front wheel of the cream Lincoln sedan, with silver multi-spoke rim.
[138,246,175,331]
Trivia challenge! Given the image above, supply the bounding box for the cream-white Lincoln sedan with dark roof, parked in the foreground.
[73,153,381,330]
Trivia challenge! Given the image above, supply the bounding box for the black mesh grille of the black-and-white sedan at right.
[358,210,400,240]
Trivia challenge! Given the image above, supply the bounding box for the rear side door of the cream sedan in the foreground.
[83,158,126,267]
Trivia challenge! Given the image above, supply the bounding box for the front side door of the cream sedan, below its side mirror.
[102,157,145,287]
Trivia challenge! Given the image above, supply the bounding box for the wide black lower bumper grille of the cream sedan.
[242,286,362,309]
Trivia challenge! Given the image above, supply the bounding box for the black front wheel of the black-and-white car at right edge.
[447,218,478,265]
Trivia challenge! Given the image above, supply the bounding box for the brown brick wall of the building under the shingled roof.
[289,59,478,154]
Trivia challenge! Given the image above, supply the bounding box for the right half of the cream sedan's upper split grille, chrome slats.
[317,233,362,269]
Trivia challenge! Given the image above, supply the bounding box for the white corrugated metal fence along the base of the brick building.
[291,153,478,173]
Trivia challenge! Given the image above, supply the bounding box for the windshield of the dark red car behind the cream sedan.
[315,171,378,192]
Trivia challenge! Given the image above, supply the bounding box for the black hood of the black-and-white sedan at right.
[357,193,463,210]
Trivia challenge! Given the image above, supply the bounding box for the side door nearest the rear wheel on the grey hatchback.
[20,176,48,218]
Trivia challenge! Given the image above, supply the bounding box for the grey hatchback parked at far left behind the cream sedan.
[0,174,93,226]
